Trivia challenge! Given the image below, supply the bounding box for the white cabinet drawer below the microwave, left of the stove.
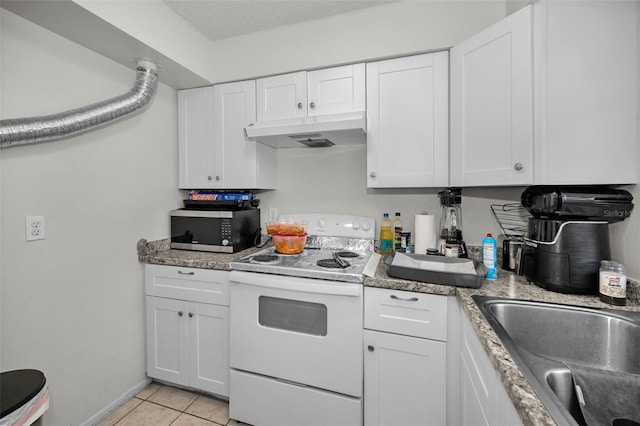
[144,264,229,306]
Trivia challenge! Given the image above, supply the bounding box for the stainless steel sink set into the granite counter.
[472,296,640,425]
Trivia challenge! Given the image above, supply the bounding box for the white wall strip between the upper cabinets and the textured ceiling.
[209,0,505,83]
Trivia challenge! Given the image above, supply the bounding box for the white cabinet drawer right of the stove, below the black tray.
[364,287,447,342]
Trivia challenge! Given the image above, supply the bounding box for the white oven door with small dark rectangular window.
[230,271,363,397]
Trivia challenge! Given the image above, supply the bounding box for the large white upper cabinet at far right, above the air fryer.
[450,1,639,186]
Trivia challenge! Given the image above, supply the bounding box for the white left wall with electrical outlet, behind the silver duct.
[0,10,181,425]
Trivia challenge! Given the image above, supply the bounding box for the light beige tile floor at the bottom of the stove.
[98,382,242,426]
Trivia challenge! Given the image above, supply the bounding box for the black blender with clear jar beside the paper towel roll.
[438,188,467,257]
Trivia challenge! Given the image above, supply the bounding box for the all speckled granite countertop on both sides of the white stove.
[138,239,640,425]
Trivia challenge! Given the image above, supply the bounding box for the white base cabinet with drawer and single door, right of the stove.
[364,287,447,426]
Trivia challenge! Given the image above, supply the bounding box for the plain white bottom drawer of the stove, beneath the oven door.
[229,370,362,426]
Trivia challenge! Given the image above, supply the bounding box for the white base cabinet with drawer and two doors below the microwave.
[145,265,229,397]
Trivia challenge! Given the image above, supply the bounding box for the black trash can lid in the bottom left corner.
[0,370,47,418]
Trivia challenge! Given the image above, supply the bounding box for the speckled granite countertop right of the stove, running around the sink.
[364,261,640,426]
